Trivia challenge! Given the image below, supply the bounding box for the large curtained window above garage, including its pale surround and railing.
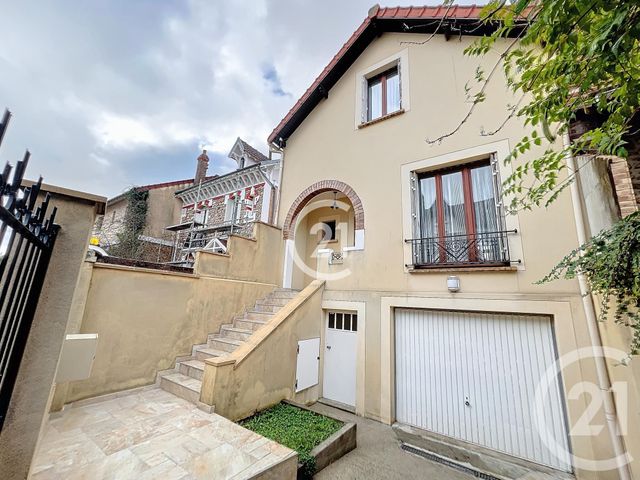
[401,140,524,271]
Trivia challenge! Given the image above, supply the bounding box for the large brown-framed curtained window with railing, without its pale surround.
[410,160,509,267]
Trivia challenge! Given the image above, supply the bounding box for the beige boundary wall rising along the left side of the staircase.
[52,224,282,404]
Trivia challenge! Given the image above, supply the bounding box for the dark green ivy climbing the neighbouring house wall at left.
[109,187,149,259]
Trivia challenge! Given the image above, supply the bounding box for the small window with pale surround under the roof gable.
[355,49,410,128]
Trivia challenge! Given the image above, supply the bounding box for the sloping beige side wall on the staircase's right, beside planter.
[200,280,324,420]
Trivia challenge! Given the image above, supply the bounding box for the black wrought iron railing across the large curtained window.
[405,230,516,268]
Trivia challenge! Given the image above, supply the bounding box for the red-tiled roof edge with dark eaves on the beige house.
[268,5,526,147]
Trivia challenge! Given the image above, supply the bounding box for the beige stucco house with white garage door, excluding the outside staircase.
[262,6,640,479]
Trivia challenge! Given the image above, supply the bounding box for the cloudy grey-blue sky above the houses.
[0,0,460,196]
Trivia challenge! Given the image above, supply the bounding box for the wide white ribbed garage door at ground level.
[395,309,571,471]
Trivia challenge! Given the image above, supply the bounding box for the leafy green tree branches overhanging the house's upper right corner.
[467,0,640,209]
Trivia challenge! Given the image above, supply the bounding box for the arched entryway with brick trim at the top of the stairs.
[283,180,364,288]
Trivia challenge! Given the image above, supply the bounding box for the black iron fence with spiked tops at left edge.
[0,111,58,430]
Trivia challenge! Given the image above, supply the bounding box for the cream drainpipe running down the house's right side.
[562,133,632,480]
